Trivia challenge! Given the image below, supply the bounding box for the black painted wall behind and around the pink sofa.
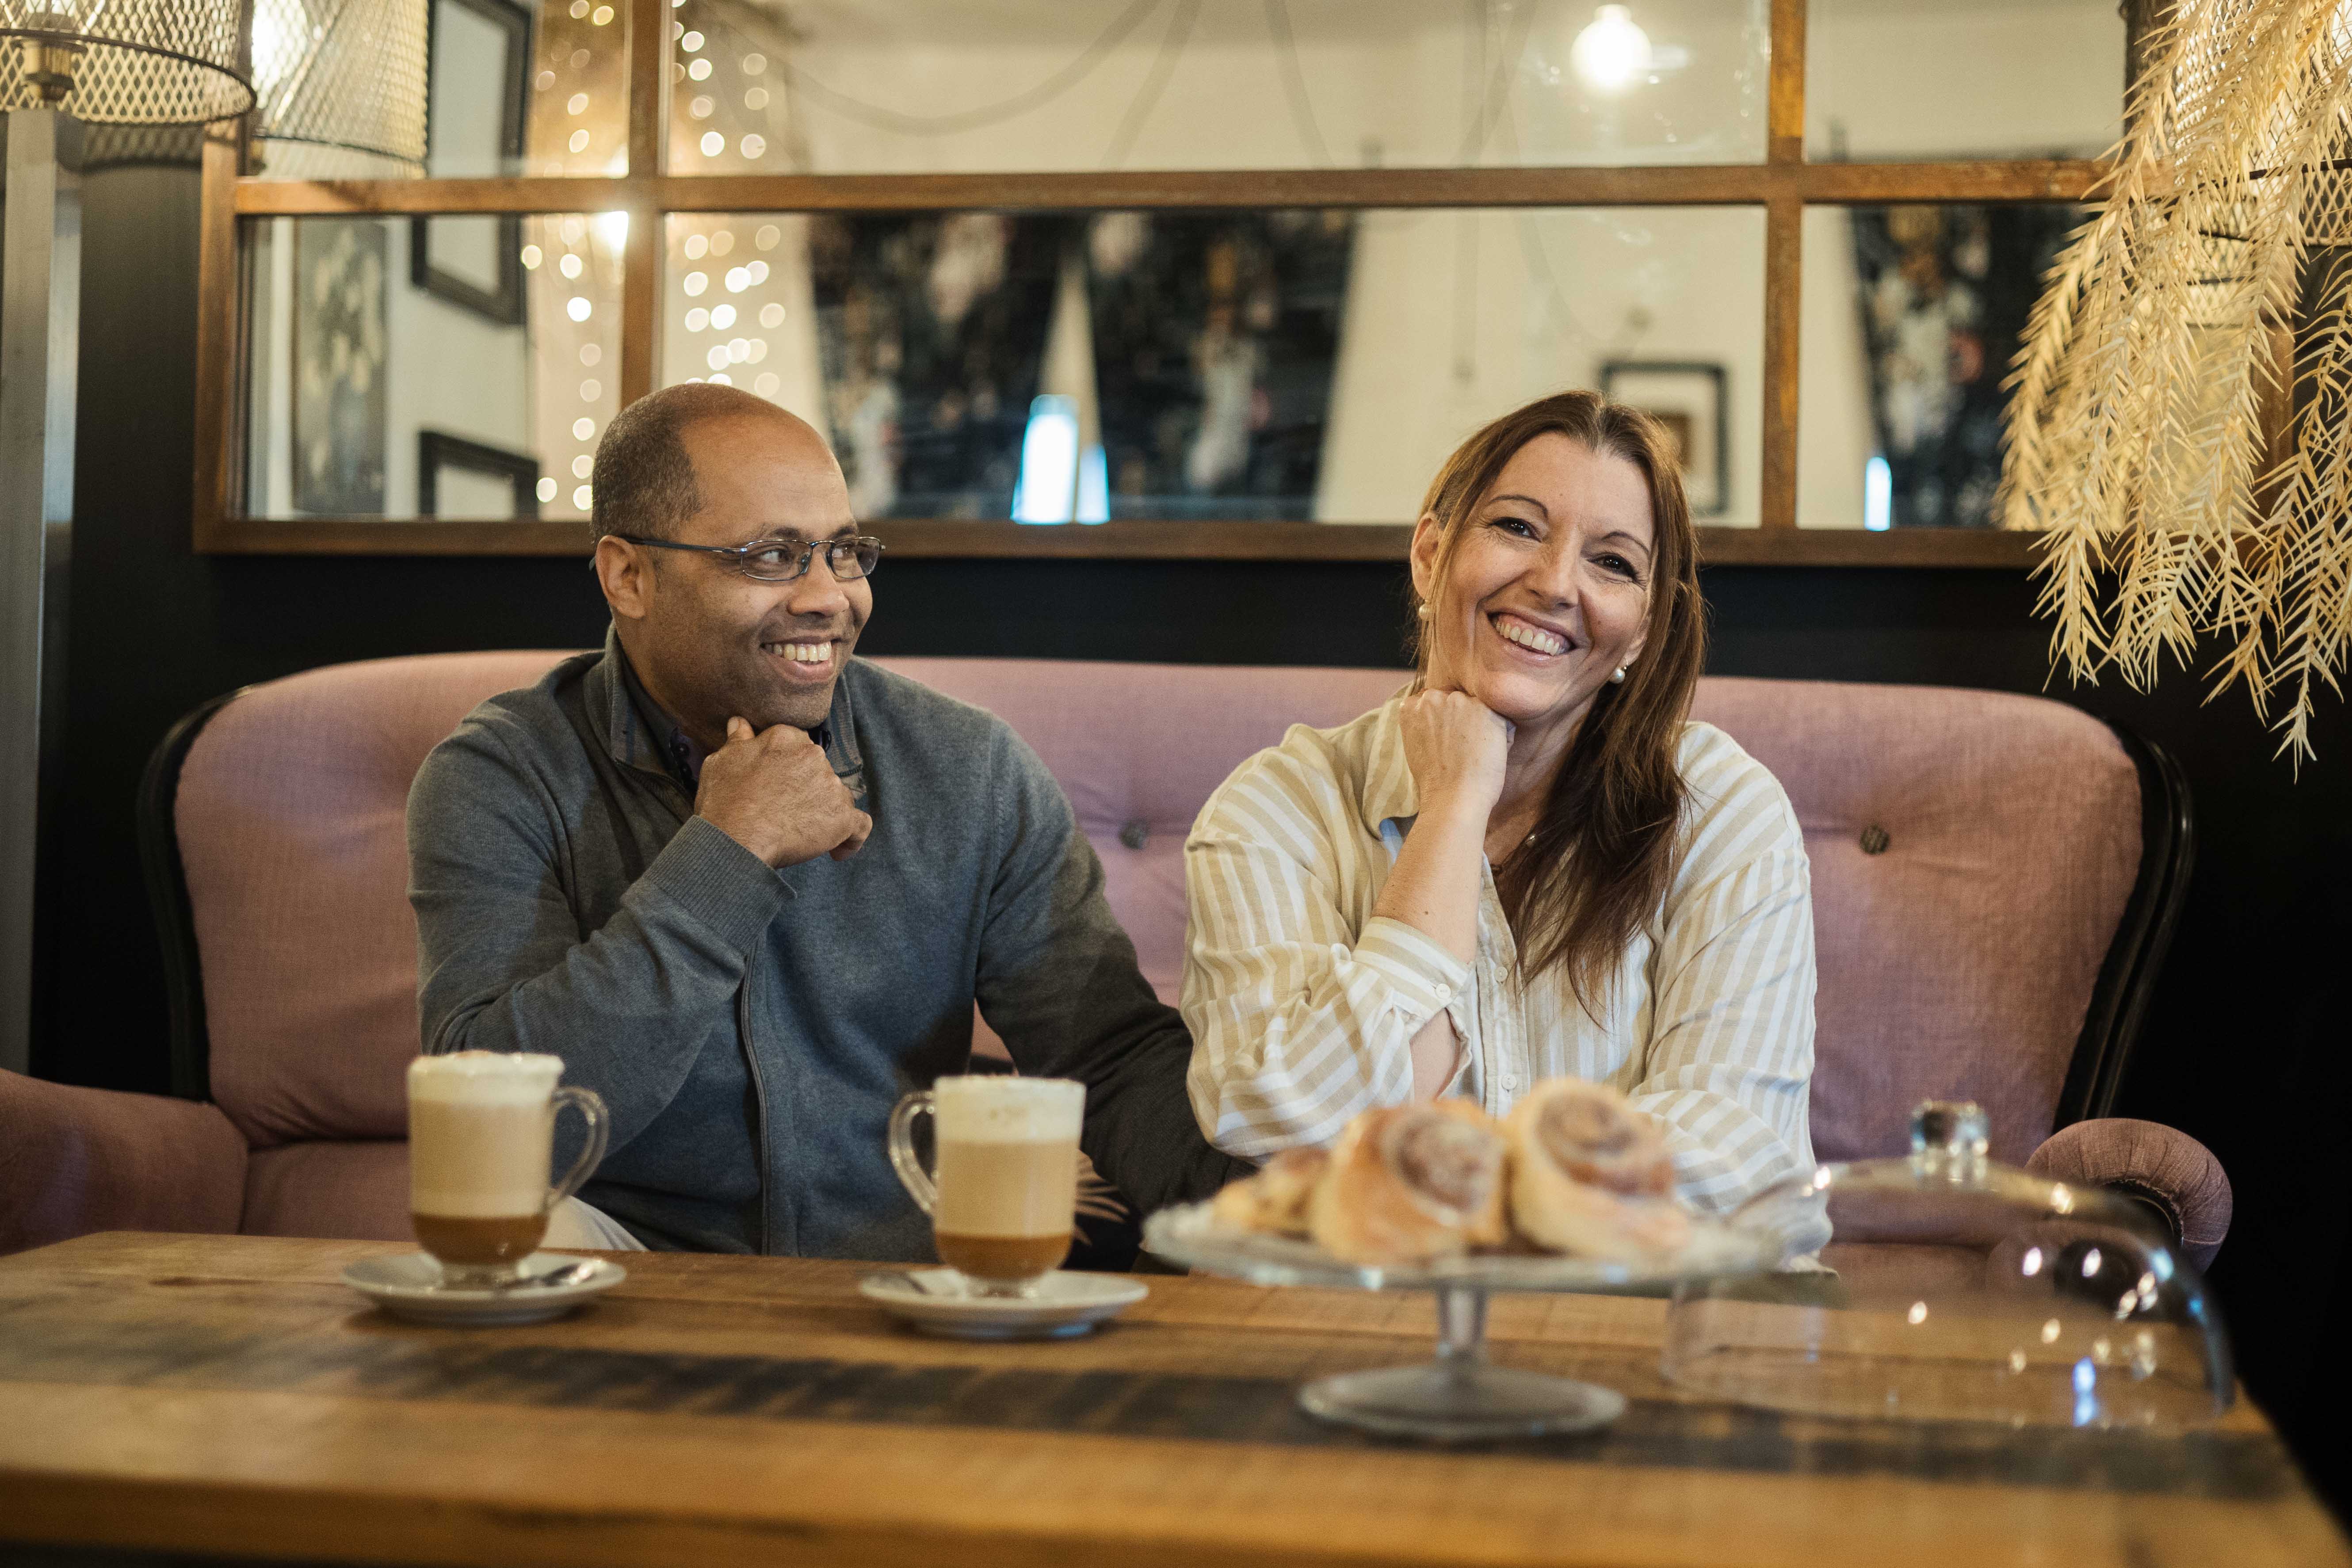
[38,169,2352,1491]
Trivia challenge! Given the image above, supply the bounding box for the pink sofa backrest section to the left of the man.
[174,653,565,1147]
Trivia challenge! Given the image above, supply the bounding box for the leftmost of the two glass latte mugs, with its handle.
[409,1051,607,1290]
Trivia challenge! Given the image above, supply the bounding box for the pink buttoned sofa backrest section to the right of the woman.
[1693,679,2140,1164]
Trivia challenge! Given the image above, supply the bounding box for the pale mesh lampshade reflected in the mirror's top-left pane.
[252,0,431,179]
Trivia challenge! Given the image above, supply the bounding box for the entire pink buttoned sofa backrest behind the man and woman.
[174,653,2140,1161]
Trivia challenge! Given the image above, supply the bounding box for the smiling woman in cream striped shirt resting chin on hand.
[1183,393,1814,1208]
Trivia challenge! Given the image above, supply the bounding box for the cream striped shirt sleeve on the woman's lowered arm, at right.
[1632,726,1814,1211]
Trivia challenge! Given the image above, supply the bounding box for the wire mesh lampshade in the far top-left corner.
[0,0,254,125]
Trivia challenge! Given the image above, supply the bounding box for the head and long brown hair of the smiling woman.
[1402,393,1705,1020]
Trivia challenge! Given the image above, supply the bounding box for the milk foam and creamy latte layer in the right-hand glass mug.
[932,1077,1087,1241]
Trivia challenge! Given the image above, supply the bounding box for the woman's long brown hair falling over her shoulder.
[1416,393,1707,1020]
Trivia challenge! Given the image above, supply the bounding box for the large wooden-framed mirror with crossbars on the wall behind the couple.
[195,0,2129,567]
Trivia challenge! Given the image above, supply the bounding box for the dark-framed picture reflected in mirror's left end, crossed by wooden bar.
[409,0,531,327]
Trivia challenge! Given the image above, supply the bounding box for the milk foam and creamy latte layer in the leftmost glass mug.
[409,1051,565,1220]
